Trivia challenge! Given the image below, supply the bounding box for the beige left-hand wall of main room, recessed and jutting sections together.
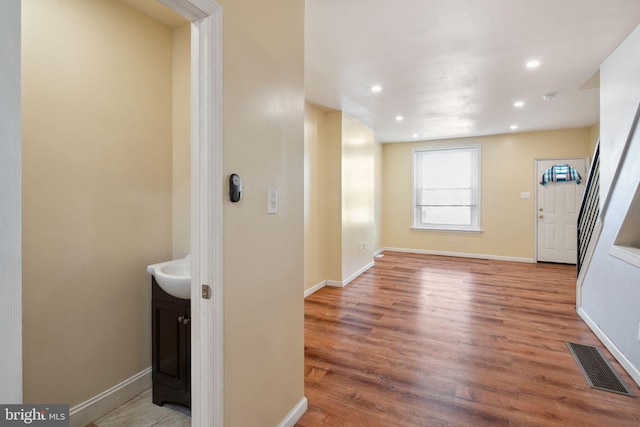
[304,103,382,290]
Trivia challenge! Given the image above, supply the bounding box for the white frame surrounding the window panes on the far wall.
[412,145,482,232]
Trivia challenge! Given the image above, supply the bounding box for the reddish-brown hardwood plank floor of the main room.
[297,252,640,427]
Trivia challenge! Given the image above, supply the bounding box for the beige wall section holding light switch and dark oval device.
[219,0,304,427]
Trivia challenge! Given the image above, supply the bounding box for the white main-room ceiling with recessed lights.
[305,0,640,142]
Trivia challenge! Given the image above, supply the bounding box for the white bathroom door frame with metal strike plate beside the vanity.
[158,0,224,427]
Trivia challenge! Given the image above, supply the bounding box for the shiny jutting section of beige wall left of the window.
[341,114,374,281]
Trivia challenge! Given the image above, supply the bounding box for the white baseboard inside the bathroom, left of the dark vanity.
[69,367,151,427]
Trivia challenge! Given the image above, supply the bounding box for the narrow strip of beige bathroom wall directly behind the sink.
[171,24,191,259]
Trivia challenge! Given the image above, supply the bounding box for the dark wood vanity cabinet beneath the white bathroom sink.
[151,276,191,408]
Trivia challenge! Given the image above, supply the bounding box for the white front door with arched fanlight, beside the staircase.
[536,158,587,264]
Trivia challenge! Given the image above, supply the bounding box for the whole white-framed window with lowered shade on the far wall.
[413,146,480,231]
